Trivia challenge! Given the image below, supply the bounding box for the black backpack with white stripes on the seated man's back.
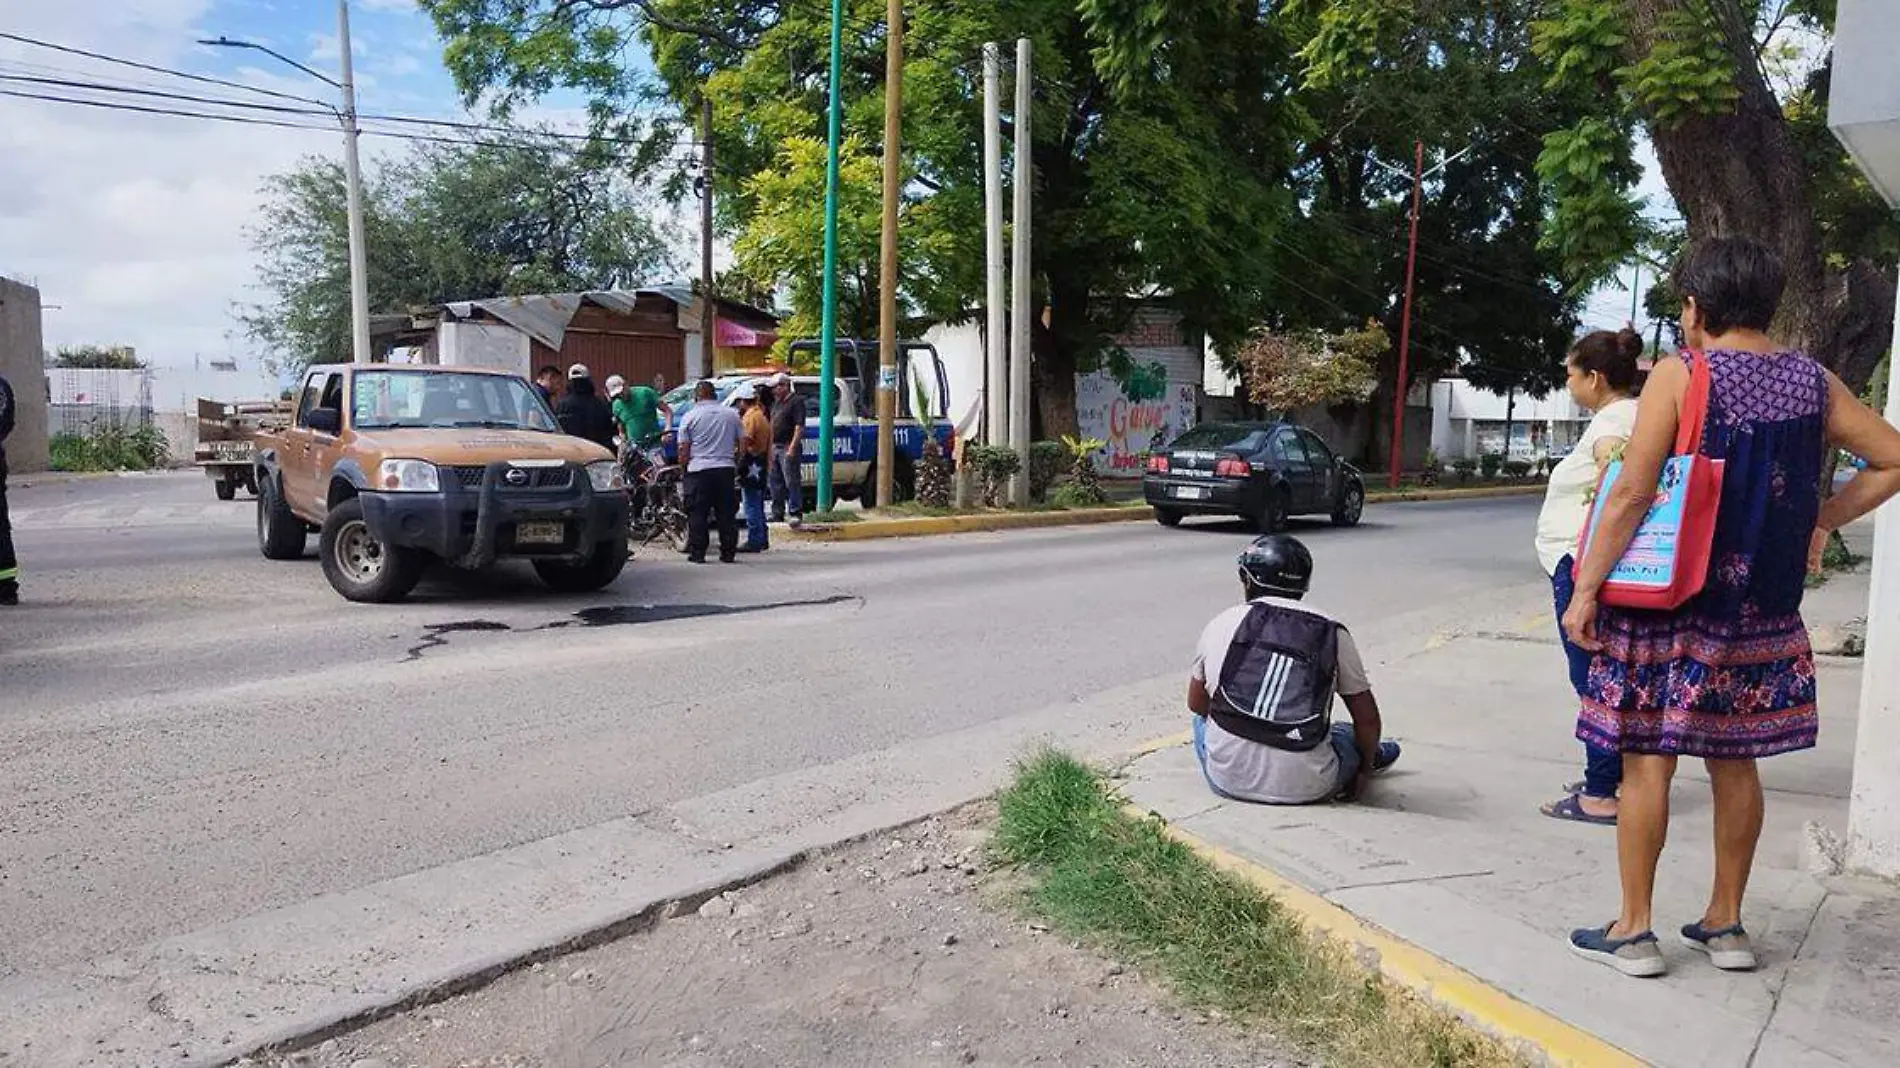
[1208,601,1340,753]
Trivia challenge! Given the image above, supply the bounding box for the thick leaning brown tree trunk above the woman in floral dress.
[1628,0,1894,391]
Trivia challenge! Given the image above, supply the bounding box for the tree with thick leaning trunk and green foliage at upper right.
[1309,0,1900,390]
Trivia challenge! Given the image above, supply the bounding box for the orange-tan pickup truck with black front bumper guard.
[255,365,627,602]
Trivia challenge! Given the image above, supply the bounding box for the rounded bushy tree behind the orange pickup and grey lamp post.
[239,135,671,367]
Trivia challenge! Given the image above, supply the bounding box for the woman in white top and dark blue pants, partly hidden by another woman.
[1537,329,1644,827]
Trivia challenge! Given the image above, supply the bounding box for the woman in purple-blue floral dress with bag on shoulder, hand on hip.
[1564,238,1900,975]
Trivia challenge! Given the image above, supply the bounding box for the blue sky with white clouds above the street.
[0,0,1668,365]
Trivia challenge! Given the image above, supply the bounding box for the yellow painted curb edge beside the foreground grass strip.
[1123,804,1645,1068]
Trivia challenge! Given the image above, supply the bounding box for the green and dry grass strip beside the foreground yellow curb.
[992,751,1528,1068]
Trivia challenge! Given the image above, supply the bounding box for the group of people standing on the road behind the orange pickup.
[534,363,808,564]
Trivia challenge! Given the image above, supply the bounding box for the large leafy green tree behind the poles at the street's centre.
[424,0,1296,437]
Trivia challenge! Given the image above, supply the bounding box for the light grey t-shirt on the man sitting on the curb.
[1193,597,1372,804]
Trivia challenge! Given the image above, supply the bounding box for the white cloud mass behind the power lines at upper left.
[0,0,412,363]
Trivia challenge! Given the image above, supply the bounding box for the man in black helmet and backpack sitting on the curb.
[1188,534,1398,804]
